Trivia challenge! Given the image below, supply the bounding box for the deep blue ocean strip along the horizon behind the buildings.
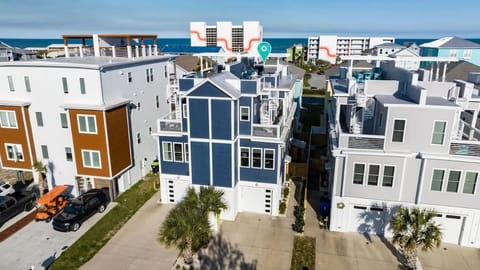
[0,38,480,53]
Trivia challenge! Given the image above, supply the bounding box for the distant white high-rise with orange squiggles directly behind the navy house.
[190,21,263,54]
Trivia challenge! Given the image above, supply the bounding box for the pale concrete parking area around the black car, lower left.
[0,203,115,270]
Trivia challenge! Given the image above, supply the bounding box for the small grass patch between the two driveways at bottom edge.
[290,236,315,270]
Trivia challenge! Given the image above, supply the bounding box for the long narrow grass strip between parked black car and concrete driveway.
[49,175,158,270]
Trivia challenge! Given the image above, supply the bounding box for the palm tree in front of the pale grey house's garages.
[390,207,442,269]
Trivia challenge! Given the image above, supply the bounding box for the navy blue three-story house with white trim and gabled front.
[155,58,302,220]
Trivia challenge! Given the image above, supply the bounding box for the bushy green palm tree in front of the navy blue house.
[158,187,227,264]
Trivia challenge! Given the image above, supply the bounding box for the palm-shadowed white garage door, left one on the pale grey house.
[348,205,388,235]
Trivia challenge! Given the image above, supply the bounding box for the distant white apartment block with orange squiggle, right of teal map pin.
[307,36,395,63]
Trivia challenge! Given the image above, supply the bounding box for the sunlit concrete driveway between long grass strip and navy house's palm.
[80,193,178,270]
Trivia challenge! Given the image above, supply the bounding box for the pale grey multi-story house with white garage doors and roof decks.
[326,61,480,248]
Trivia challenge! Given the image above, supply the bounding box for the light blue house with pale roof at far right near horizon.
[420,37,480,66]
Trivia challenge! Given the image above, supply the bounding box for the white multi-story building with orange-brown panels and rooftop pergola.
[0,35,174,197]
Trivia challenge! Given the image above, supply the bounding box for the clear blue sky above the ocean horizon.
[0,0,480,38]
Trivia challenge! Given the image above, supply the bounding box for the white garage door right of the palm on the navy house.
[240,186,273,214]
